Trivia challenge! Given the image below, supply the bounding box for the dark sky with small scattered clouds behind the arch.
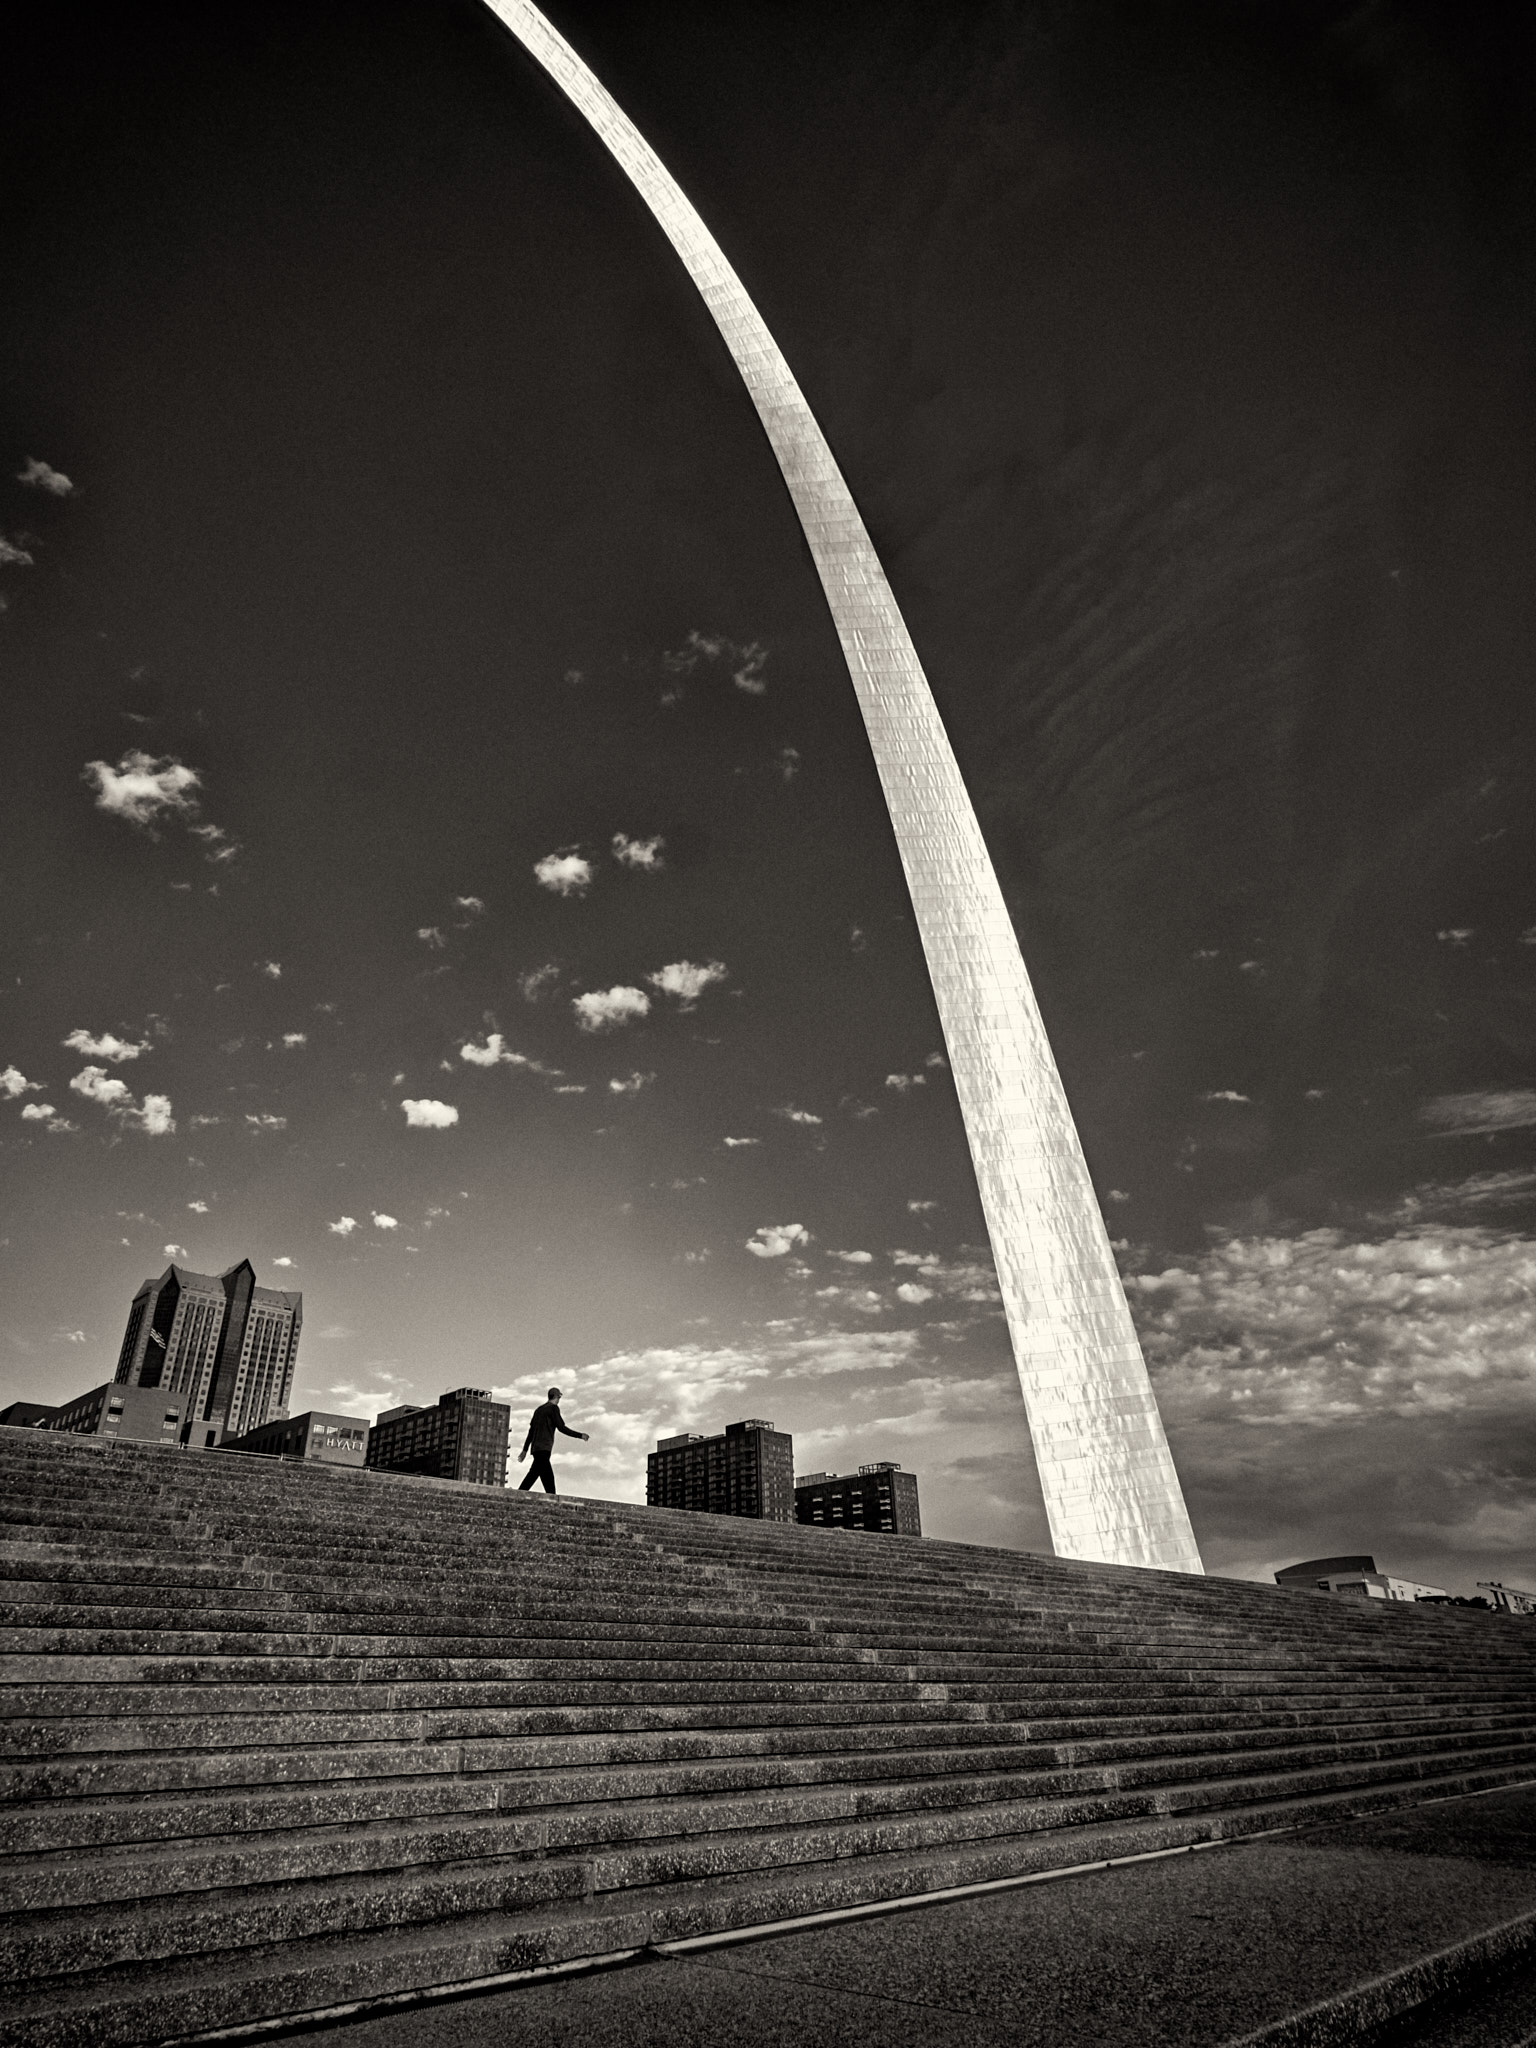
[0,0,1536,1593]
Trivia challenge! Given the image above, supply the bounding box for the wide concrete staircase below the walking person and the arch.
[0,1430,1536,2048]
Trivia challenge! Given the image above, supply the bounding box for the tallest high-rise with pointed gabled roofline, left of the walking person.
[115,1260,303,1450]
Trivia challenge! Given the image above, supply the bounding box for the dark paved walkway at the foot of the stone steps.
[309,1788,1536,2048]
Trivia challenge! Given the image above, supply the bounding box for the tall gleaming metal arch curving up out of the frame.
[485,0,1202,1571]
